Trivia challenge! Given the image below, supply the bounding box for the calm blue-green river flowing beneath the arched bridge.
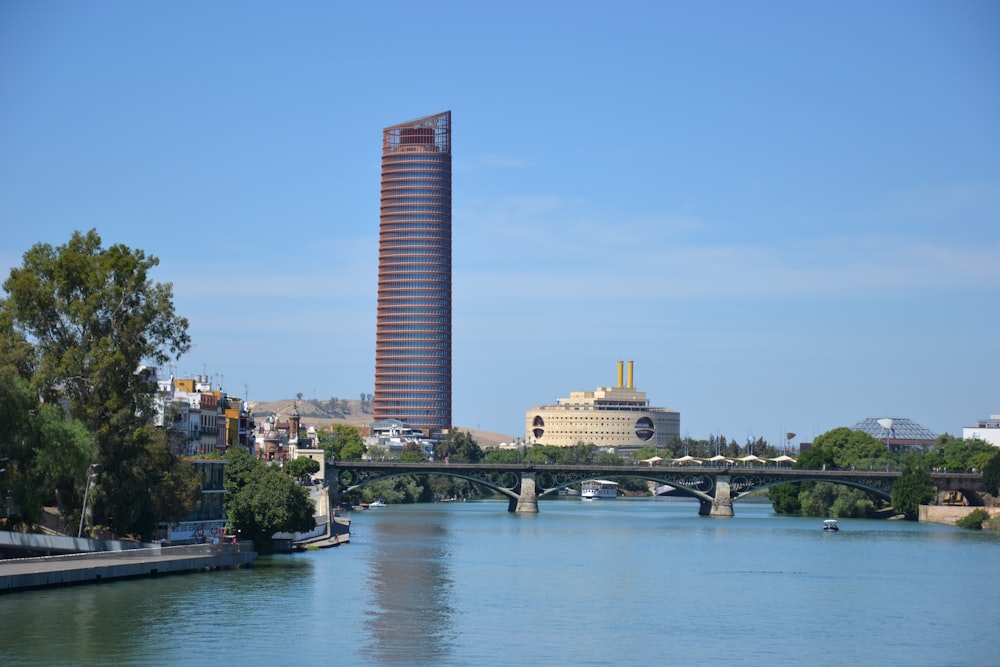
[0,498,1000,667]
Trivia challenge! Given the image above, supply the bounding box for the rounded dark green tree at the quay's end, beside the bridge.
[224,447,316,553]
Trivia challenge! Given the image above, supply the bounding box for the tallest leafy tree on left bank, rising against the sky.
[2,230,190,537]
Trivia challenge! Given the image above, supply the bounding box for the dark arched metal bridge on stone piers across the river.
[327,461,984,517]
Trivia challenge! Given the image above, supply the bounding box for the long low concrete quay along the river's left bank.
[0,542,257,593]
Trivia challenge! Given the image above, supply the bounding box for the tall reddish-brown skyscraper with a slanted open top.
[374,111,452,435]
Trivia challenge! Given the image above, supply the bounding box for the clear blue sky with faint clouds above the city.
[0,0,1000,442]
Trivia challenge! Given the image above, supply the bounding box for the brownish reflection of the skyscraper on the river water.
[365,513,457,664]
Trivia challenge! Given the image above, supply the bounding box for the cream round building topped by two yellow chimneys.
[525,361,681,449]
